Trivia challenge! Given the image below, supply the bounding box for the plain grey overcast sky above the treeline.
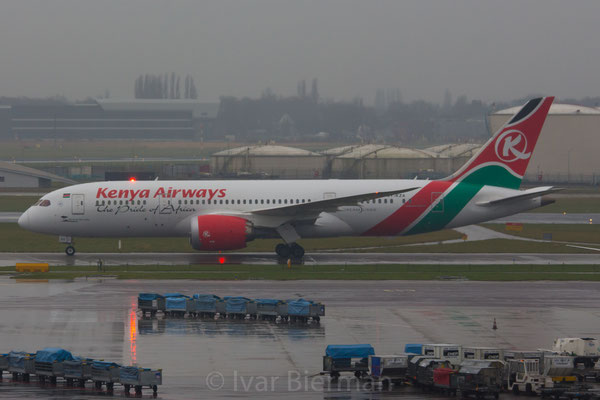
[0,0,600,103]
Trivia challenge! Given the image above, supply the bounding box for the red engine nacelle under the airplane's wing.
[190,215,254,251]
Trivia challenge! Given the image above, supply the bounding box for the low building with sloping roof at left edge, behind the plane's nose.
[0,161,76,188]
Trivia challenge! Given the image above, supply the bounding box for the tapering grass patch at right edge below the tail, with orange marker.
[483,224,600,244]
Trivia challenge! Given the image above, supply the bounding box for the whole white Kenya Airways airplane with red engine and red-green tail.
[19,97,555,258]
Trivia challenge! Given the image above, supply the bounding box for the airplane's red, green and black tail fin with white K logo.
[446,97,554,189]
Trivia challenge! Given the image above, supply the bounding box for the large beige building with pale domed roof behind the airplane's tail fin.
[489,103,600,184]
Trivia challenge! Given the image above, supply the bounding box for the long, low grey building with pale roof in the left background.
[0,99,219,139]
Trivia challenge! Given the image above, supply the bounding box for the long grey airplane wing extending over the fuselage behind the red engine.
[252,187,420,217]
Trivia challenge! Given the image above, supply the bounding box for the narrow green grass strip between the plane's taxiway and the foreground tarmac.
[8,264,600,281]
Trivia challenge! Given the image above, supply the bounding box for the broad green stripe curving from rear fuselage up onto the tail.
[406,165,521,235]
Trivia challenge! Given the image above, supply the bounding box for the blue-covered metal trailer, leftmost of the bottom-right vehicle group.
[321,344,375,379]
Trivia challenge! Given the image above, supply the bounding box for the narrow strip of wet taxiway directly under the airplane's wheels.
[0,252,600,266]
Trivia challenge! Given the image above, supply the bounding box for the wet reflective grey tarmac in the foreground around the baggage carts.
[0,278,600,399]
